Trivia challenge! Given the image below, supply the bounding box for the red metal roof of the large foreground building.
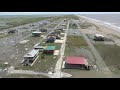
[66,57,87,65]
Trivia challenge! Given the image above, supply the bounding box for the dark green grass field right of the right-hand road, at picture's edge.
[95,45,120,66]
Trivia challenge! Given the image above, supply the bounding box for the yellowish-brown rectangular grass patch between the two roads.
[67,35,88,47]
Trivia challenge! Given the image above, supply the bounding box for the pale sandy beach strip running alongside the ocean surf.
[80,16,120,46]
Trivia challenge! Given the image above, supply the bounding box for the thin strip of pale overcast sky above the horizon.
[0,12,120,15]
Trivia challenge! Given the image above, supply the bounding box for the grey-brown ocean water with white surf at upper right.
[81,14,120,31]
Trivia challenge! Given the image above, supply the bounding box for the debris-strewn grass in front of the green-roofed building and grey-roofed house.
[15,53,58,72]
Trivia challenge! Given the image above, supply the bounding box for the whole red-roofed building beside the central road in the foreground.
[65,56,89,69]
